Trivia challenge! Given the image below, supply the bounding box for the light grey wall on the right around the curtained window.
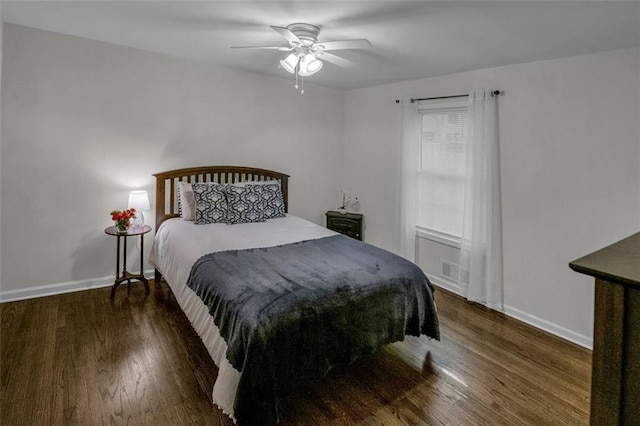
[345,48,640,345]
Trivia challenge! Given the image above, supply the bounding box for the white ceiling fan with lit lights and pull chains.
[231,22,372,93]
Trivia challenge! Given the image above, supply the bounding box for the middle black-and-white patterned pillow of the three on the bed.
[225,184,265,225]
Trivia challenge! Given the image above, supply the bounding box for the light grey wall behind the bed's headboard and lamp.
[0,24,344,300]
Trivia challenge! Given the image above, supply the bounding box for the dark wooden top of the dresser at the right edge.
[569,232,640,288]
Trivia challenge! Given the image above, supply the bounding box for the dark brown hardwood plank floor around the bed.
[0,283,591,426]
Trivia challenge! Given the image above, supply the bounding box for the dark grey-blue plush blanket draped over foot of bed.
[188,235,439,425]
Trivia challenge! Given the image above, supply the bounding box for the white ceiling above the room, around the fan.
[1,0,640,89]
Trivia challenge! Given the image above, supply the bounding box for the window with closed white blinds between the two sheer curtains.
[417,103,468,240]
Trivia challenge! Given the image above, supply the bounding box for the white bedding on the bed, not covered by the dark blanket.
[149,215,336,421]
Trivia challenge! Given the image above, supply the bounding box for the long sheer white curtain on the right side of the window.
[460,90,504,312]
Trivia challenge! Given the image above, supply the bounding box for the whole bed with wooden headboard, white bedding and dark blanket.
[150,166,439,425]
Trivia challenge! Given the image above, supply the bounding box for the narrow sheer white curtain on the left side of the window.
[397,98,420,262]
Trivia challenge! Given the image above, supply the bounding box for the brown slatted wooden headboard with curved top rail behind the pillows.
[153,166,289,230]
